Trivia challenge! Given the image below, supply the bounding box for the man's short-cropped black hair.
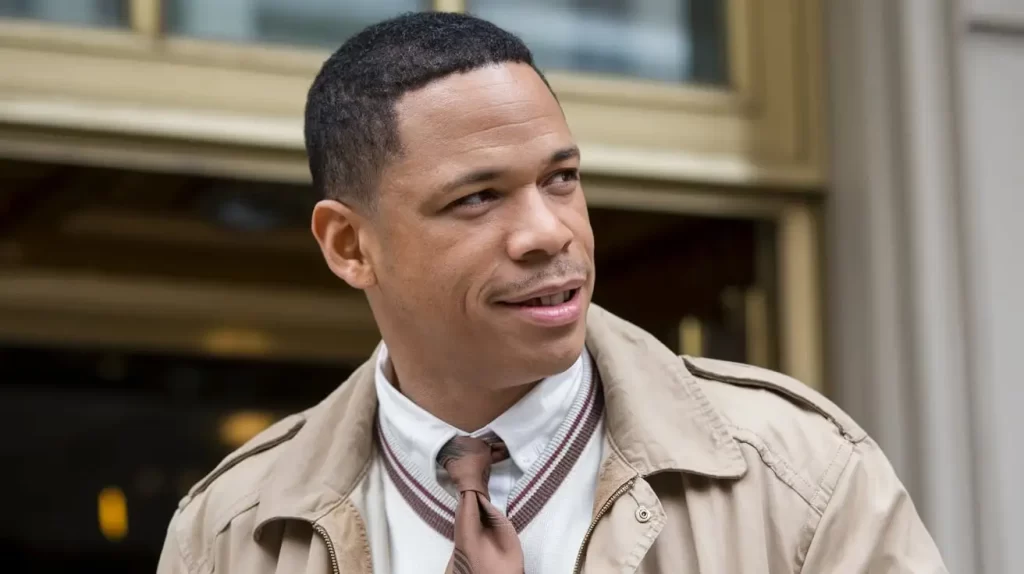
[305,12,550,207]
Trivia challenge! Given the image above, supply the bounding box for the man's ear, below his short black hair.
[312,200,377,290]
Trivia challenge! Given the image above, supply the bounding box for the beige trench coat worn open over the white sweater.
[159,306,946,574]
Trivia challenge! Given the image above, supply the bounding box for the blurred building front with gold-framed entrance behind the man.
[0,0,1024,573]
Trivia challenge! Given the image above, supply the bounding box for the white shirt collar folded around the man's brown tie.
[374,344,590,476]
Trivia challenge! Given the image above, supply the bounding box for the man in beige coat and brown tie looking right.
[160,13,945,574]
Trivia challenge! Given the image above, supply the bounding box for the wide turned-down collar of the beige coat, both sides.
[256,304,746,535]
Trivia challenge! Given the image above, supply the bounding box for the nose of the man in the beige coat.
[508,189,572,261]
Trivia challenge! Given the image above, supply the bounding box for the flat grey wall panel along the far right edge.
[958,0,1024,572]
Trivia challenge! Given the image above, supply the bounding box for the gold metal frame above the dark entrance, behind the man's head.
[0,0,824,190]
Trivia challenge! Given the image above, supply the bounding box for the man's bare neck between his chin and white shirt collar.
[384,357,540,433]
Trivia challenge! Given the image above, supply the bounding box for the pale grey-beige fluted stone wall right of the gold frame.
[826,0,1024,574]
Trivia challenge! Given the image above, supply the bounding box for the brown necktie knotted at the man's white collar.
[437,437,524,574]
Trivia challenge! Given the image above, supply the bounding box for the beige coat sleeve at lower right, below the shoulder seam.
[801,438,948,574]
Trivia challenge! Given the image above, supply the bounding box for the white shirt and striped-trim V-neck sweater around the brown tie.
[374,346,603,574]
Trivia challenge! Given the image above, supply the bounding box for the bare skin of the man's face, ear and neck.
[312,63,594,432]
